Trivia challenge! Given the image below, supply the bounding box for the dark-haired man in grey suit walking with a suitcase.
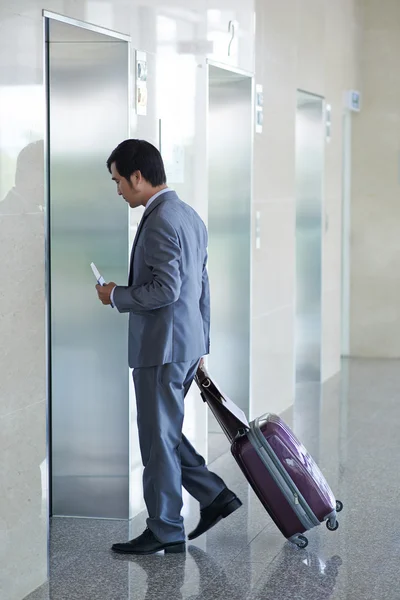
[97,140,241,554]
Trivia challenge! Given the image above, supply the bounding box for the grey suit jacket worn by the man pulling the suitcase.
[114,191,210,368]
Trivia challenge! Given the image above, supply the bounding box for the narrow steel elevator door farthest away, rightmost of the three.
[296,92,325,383]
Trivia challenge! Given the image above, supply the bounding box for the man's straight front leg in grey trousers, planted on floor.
[133,363,191,542]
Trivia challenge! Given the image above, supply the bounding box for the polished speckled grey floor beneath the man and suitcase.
[24,360,400,600]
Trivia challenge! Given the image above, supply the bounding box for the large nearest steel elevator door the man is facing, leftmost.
[47,19,129,518]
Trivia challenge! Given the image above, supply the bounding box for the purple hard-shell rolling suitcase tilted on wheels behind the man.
[196,366,343,548]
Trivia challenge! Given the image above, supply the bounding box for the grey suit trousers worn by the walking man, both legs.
[133,359,225,542]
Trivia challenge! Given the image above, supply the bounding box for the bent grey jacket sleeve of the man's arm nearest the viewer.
[114,219,182,314]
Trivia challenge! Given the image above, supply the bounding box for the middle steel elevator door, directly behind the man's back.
[208,65,252,422]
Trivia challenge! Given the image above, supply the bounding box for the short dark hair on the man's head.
[107,140,167,187]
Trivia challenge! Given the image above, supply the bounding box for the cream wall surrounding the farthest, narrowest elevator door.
[252,0,360,416]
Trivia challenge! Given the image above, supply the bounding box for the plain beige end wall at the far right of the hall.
[350,0,400,358]
